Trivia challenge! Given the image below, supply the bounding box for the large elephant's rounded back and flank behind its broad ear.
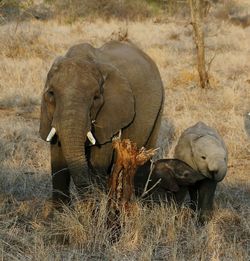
[96,41,164,147]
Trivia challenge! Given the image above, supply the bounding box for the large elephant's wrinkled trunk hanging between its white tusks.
[59,110,91,195]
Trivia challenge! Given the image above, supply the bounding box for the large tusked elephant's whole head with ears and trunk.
[39,56,135,192]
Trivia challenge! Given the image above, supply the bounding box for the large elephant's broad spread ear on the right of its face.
[95,64,135,144]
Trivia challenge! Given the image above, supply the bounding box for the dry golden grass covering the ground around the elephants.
[0,3,250,260]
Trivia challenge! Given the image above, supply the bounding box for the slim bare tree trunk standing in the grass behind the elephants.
[189,0,210,88]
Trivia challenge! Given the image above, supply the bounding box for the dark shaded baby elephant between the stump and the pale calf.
[143,159,206,198]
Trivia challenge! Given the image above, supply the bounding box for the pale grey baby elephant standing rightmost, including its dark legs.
[174,122,228,222]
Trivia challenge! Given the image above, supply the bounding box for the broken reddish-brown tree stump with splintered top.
[108,139,155,242]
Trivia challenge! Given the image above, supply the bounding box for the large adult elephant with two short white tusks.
[40,41,164,202]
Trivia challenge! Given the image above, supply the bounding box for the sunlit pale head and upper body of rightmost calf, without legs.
[175,122,228,182]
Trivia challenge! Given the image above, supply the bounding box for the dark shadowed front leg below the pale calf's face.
[197,179,217,224]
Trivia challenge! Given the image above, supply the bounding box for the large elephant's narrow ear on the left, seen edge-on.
[39,56,63,141]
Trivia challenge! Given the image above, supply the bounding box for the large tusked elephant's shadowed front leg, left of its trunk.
[50,142,70,205]
